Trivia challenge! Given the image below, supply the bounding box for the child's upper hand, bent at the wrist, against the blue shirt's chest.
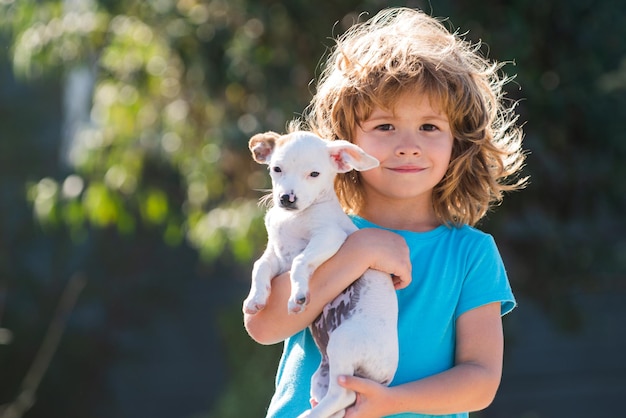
[344,228,411,289]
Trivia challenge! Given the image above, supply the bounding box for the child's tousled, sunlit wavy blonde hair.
[303,8,526,225]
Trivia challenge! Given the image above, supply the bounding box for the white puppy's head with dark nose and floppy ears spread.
[248,131,378,210]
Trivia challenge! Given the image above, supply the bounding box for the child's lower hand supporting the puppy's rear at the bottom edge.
[339,376,389,418]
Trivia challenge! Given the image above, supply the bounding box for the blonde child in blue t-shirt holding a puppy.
[244,8,524,418]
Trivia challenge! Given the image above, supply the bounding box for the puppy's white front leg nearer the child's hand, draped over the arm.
[288,228,348,313]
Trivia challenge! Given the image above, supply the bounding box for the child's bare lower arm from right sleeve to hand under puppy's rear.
[340,303,504,418]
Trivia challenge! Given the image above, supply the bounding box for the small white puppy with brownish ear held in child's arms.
[243,131,398,418]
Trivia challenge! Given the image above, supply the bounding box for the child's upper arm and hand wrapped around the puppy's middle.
[244,228,411,344]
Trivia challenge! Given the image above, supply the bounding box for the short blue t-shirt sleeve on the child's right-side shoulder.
[455,234,516,318]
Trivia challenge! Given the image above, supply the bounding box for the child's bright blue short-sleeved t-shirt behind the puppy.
[267,216,515,418]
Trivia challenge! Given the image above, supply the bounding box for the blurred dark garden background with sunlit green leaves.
[0,0,626,418]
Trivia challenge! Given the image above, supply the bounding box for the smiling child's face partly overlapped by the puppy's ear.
[354,93,454,207]
